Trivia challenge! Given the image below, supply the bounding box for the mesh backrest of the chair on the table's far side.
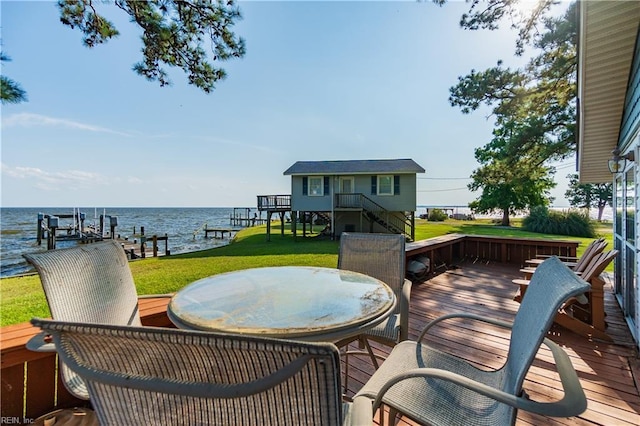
[338,232,406,311]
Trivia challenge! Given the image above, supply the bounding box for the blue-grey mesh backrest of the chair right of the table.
[503,256,589,394]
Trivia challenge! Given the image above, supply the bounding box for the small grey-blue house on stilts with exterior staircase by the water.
[284,159,424,240]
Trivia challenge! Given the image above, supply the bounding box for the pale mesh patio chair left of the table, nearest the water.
[24,240,171,399]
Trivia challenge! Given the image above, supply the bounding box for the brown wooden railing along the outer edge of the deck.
[0,234,579,424]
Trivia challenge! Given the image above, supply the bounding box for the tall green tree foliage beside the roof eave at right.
[449,0,577,225]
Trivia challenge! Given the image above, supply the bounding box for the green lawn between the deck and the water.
[0,220,612,326]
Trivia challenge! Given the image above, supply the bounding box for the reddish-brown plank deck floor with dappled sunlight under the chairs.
[348,262,640,425]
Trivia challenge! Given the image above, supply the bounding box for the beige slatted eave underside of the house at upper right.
[578,0,640,183]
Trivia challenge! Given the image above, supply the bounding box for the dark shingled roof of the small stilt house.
[284,158,424,175]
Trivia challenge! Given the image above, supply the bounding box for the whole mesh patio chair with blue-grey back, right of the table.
[356,257,589,426]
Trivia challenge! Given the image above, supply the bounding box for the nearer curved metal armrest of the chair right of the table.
[373,338,587,417]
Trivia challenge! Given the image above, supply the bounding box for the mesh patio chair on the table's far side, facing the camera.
[336,232,411,387]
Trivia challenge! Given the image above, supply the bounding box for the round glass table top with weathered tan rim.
[168,266,396,338]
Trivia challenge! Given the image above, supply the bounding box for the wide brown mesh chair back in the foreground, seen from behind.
[32,319,343,425]
